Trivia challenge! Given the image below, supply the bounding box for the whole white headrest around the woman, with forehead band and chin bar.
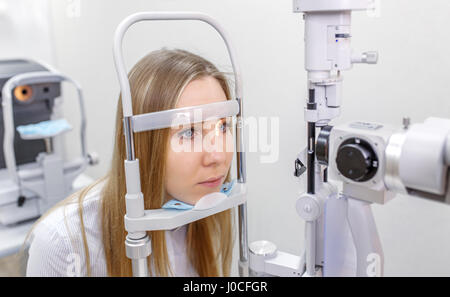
[113,12,248,276]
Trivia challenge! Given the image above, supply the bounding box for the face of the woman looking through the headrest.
[165,76,234,205]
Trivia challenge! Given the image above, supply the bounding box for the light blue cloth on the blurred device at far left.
[16,119,72,138]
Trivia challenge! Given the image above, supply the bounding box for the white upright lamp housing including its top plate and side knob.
[293,0,378,127]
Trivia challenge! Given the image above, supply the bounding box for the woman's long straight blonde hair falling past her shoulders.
[25,49,234,276]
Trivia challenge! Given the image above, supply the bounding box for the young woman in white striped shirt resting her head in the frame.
[27,49,234,276]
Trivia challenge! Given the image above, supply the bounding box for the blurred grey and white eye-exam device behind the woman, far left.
[0,60,97,225]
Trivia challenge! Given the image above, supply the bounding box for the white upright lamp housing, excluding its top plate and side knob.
[304,11,352,127]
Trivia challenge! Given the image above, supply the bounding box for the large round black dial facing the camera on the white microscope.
[336,138,378,182]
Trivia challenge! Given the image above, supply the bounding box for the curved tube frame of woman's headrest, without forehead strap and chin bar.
[113,12,248,276]
